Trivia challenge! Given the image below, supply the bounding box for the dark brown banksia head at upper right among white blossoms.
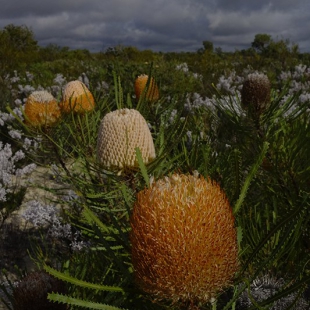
[241,73,270,115]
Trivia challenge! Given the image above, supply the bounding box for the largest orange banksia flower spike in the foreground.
[130,174,238,308]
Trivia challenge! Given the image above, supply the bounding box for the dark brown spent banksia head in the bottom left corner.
[13,271,67,310]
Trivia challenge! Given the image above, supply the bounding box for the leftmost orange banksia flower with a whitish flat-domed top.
[24,90,61,127]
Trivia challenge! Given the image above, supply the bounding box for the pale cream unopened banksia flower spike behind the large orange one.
[97,109,155,169]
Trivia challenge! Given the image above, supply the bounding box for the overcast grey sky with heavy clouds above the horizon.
[0,0,310,52]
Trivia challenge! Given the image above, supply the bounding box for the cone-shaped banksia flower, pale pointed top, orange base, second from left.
[60,80,95,113]
